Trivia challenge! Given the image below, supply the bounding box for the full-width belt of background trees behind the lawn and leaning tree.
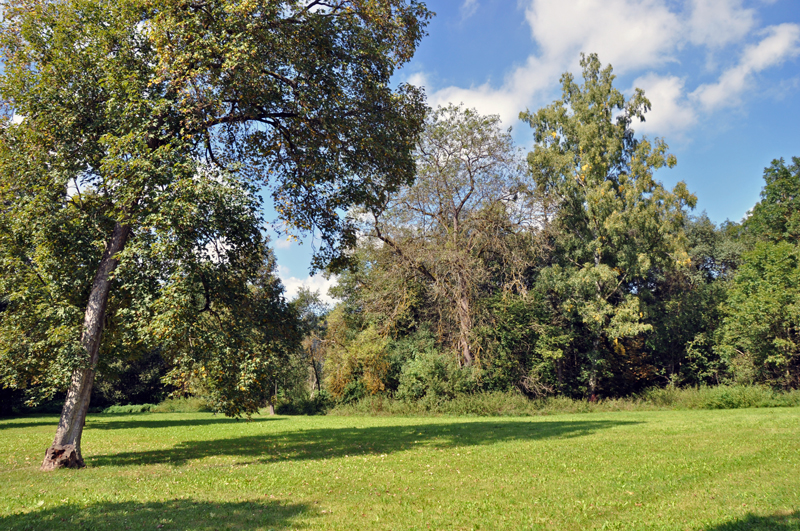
[0,55,800,415]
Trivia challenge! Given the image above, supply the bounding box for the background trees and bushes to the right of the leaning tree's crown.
[306,56,800,403]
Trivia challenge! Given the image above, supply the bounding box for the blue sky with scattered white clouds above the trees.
[267,0,800,302]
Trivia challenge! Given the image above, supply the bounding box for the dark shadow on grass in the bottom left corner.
[0,500,317,531]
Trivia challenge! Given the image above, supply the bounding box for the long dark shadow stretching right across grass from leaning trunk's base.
[89,420,638,466]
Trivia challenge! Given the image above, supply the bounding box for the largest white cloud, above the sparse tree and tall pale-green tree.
[424,0,680,128]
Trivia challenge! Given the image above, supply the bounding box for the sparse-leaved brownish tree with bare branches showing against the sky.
[367,105,533,365]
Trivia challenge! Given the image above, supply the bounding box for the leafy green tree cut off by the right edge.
[718,157,800,388]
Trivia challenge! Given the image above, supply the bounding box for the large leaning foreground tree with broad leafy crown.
[0,0,430,468]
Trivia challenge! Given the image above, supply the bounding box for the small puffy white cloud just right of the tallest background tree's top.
[633,72,697,136]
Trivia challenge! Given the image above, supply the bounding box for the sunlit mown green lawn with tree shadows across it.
[0,408,800,531]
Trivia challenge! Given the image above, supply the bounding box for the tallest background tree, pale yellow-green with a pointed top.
[520,54,696,396]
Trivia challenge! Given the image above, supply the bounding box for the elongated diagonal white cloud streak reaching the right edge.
[691,24,800,110]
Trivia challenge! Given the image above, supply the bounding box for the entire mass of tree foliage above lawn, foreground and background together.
[0,0,800,426]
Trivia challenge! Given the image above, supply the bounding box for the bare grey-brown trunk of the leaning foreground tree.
[42,223,130,470]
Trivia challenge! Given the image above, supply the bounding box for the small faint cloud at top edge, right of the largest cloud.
[688,0,755,48]
